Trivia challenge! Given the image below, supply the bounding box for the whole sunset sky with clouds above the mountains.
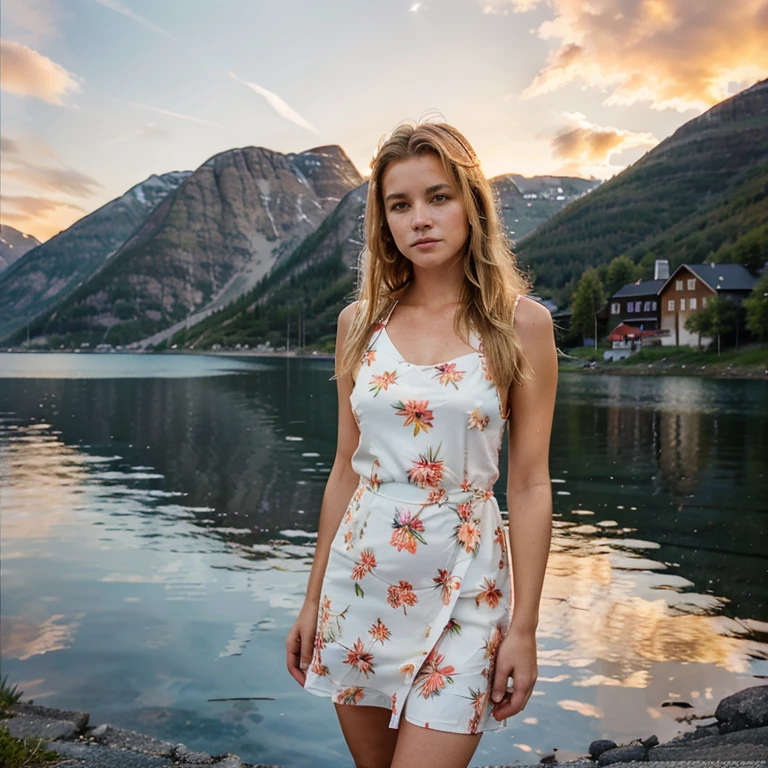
[0,0,768,241]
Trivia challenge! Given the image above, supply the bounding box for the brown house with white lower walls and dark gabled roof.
[659,264,757,347]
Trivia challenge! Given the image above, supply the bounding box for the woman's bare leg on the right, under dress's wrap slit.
[391,717,482,768]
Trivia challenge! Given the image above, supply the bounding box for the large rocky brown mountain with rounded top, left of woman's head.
[3,146,362,345]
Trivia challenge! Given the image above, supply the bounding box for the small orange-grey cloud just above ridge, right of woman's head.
[551,112,659,178]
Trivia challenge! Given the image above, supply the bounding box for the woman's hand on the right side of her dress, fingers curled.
[491,625,538,720]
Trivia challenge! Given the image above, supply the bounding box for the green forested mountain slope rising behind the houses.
[518,80,768,291]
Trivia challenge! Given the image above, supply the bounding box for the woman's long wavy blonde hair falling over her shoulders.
[335,122,529,414]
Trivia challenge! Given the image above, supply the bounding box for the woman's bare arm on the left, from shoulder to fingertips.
[285,303,360,686]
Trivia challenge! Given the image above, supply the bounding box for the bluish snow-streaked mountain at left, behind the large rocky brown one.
[0,171,190,337]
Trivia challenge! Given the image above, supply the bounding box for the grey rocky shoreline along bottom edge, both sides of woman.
[0,685,768,768]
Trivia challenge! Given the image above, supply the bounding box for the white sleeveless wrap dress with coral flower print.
[304,301,512,733]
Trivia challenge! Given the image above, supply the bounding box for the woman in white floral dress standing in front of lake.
[286,123,557,768]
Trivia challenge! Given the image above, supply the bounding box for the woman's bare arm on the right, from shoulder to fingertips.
[491,298,557,720]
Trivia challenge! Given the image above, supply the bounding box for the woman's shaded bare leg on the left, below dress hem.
[335,704,398,768]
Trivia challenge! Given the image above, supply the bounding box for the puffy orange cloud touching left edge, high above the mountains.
[0,40,80,106]
